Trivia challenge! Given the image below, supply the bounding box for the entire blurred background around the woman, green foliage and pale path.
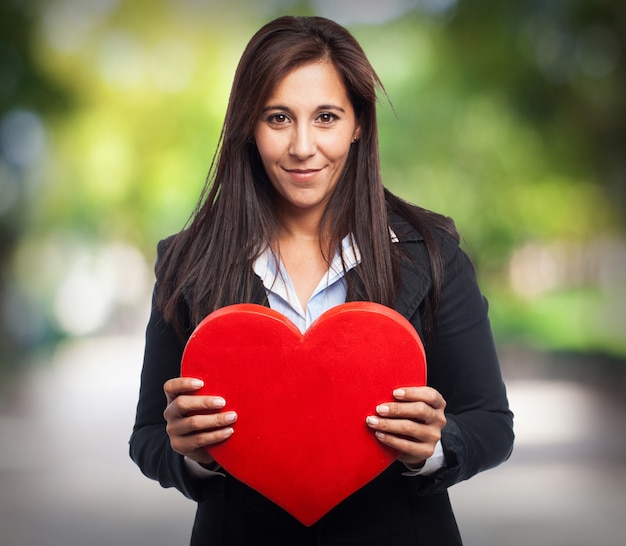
[0,4,626,546]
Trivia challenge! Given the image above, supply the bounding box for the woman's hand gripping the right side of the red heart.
[367,387,446,468]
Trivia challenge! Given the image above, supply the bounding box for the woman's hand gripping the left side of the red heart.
[163,377,237,465]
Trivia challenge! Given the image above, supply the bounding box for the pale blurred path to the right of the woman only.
[450,368,626,546]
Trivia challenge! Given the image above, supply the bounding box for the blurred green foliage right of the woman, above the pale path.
[355,0,626,355]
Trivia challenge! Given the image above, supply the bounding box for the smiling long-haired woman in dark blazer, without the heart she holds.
[130,17,513,546]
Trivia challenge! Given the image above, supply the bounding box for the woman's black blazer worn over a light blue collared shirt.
[130,215,513,546]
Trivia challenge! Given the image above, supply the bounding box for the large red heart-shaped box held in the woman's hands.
[181,302,426,526]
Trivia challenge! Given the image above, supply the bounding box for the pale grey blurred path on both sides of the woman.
[0,336,626,546]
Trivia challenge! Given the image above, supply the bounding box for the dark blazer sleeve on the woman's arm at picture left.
[129,241,219,501]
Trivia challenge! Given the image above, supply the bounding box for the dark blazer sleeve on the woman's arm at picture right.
[410,234,514,494]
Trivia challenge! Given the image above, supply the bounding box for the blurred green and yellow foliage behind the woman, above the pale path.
[0,0,626,384]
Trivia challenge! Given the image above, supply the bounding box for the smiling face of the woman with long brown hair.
[254,62,360,216]
